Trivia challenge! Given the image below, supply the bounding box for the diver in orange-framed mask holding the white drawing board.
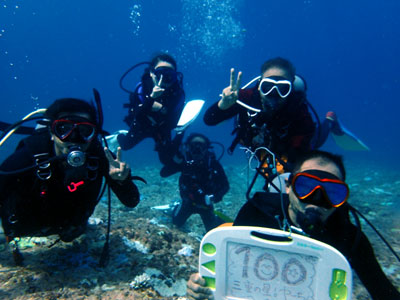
[188,150,400,300]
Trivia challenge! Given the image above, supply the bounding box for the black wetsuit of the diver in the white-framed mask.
[204,86,316,166]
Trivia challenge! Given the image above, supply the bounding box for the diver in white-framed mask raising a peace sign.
[204,57,337,171]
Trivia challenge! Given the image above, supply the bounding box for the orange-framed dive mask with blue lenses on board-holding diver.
[289,170,349,209]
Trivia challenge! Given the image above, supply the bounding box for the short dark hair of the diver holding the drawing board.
[293,150,346,181]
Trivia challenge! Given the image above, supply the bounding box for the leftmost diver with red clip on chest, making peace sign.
[0,97,139,264]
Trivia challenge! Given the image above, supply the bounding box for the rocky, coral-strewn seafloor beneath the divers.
[0,159,400,300]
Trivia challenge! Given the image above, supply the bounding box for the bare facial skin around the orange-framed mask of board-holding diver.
[286,158,342,227]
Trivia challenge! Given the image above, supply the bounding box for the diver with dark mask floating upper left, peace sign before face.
[117,53,185,172]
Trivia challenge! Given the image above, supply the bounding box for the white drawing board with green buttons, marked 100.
[199,226,352,300]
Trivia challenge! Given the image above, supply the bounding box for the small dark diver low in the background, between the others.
[172,133,229,231]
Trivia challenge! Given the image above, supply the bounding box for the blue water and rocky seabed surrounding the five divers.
[0,0,400,300]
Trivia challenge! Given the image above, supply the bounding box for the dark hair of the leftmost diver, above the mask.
[45,98,98,125]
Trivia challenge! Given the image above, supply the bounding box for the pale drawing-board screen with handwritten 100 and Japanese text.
[225,242,318,300]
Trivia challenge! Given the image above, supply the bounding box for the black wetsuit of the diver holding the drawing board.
[234,193,400,300]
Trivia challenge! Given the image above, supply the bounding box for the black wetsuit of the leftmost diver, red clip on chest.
[0,131,139,241]
